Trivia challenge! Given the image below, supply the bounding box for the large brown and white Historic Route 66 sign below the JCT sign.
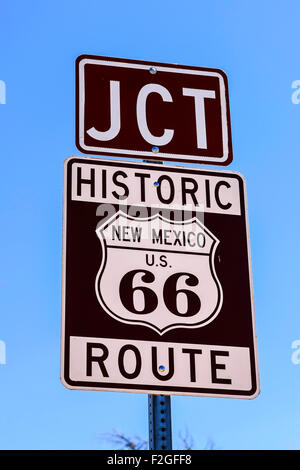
[61,157,259,398]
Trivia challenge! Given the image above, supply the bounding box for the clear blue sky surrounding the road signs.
[0,0,300,449]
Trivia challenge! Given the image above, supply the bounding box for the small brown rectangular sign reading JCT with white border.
[76,55,232,165]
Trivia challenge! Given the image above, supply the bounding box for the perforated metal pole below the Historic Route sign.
[148,395,172,450]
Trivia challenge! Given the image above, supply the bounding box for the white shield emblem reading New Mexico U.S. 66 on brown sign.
[95,211,223,335]
